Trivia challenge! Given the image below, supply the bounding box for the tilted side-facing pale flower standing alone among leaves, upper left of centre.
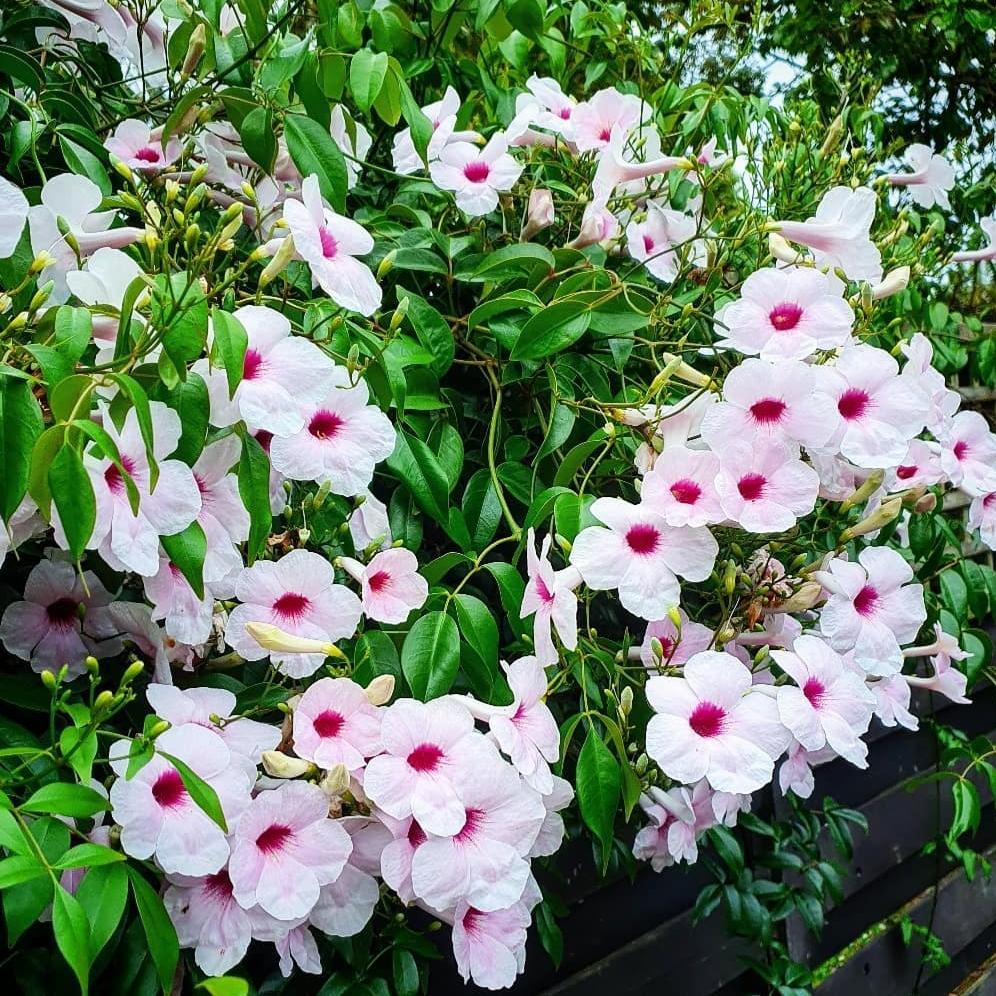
[284,174,382,316]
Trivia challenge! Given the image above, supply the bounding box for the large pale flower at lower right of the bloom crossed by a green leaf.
[228,782,353,920]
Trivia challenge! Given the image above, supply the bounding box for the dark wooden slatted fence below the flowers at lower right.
[430,687,996,996]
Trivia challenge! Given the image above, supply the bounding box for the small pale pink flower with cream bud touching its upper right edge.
[294,678,380,771]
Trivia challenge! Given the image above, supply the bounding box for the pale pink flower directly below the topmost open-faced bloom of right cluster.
[702,359,840,452]
